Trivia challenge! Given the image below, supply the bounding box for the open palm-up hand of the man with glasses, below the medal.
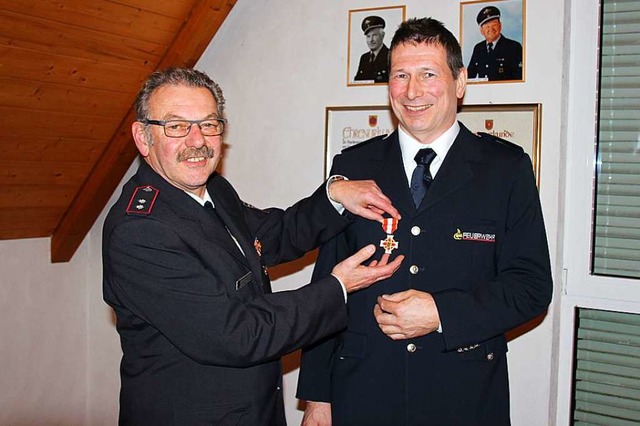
[331,244,404,293]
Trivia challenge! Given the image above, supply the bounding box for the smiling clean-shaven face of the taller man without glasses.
[389,43,467,144]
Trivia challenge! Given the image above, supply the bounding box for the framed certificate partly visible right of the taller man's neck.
[458,104,542,187]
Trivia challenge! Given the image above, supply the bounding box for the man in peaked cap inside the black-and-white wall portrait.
[353,16,389,83]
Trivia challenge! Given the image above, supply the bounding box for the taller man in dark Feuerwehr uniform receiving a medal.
[298,18,552,426]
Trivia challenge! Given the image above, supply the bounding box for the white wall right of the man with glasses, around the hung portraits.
[198,0,565,425]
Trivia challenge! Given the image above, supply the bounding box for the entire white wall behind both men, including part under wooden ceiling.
[0,0,566,426]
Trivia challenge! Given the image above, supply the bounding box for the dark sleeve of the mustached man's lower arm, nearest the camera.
[103,218,346,367]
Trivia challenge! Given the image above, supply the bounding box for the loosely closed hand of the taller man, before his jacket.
[373,290,440,340]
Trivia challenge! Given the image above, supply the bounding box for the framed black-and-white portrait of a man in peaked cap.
[347,6,406,86]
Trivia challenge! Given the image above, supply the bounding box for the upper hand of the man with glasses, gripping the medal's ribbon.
[329,180,400,222]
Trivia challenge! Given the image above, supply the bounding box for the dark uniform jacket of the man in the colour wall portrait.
[467,35,522,81]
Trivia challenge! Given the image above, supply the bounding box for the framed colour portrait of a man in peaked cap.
[460,0,526,84]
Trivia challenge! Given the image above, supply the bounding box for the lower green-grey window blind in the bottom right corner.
[573,308,640,426]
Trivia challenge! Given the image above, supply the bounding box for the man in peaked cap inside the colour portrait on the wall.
[467,6,522,81]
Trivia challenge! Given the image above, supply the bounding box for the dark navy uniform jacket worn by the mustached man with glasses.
[103,162,349,426]
